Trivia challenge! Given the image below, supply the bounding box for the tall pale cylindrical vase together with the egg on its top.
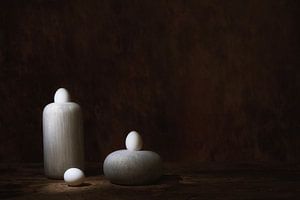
[43,88,84,179]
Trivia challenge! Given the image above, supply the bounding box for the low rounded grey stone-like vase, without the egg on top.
[103,150,163,185]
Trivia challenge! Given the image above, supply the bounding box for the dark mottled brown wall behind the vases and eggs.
[0,0,300,162]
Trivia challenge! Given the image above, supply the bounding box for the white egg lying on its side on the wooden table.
[64,168,85,186]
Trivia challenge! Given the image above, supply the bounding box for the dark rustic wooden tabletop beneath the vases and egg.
[0,163,300,200]
